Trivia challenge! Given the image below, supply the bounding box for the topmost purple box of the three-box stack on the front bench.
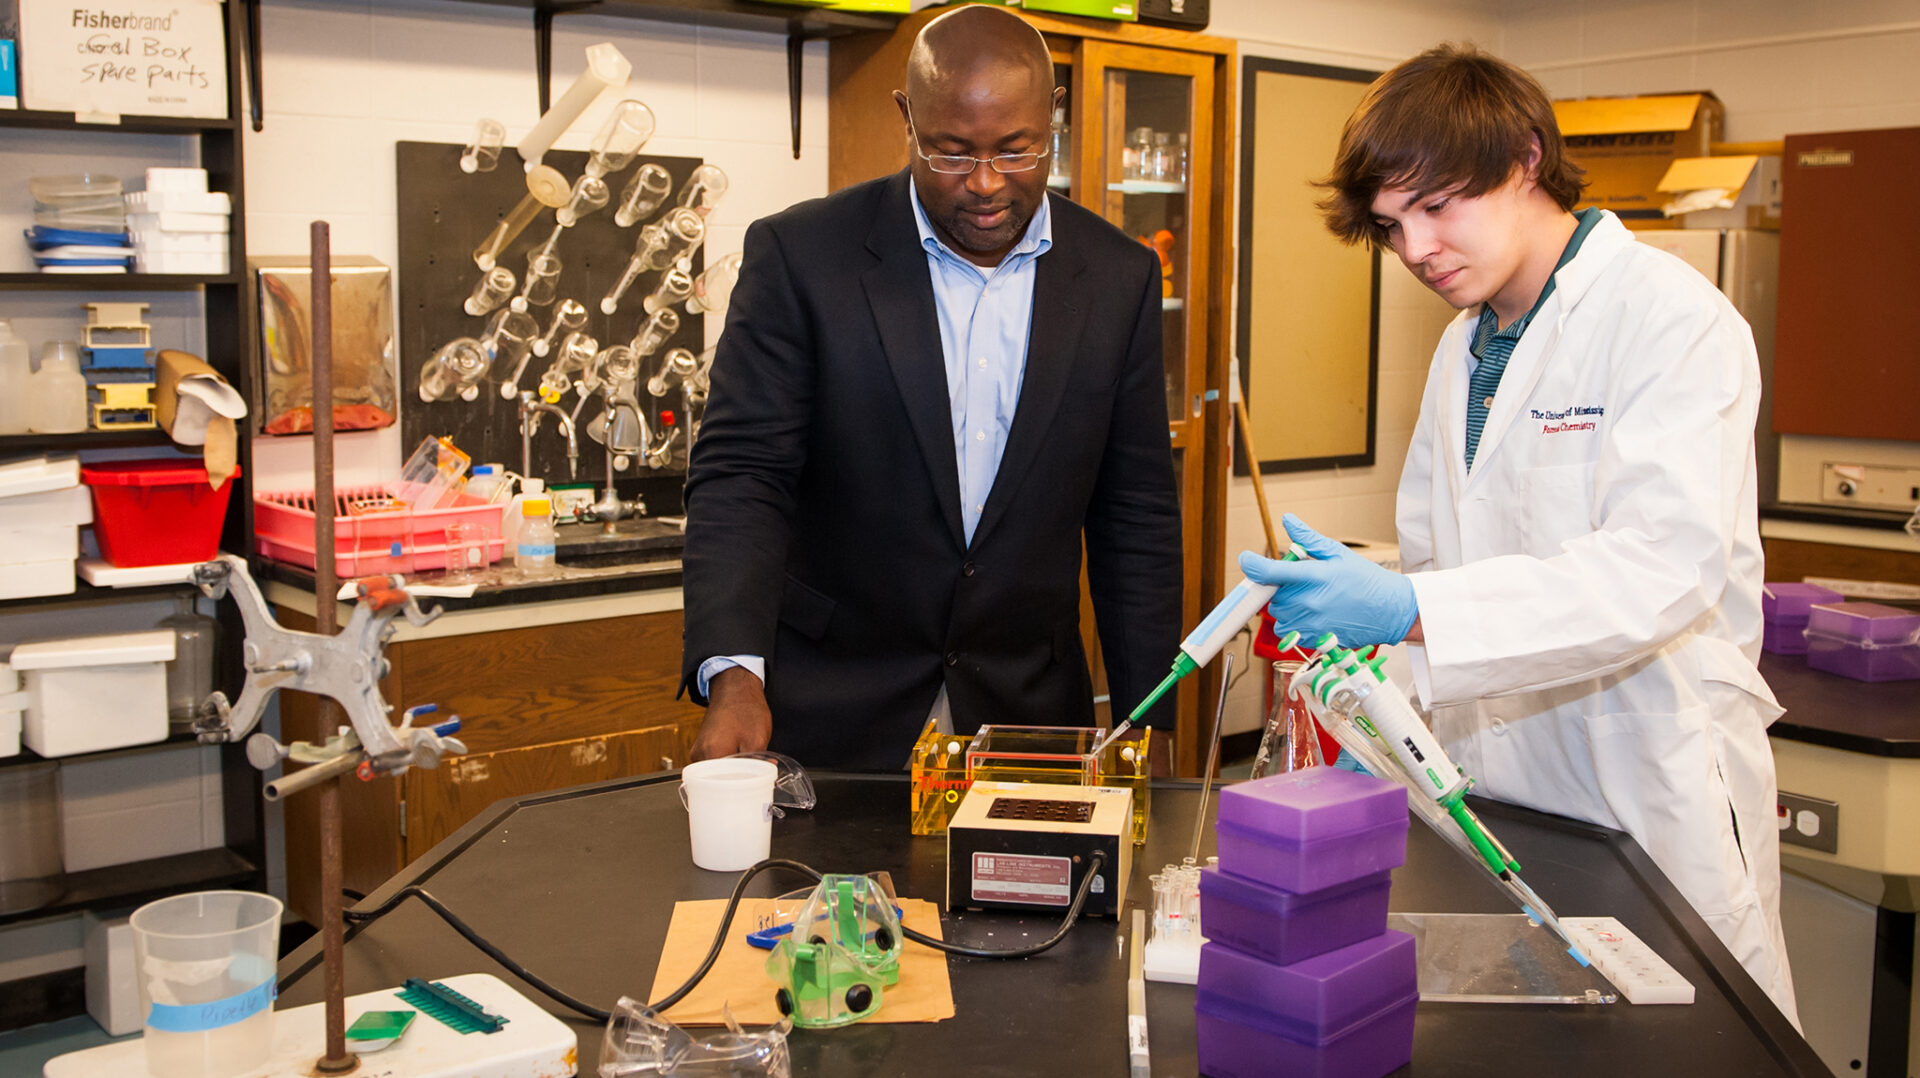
[1202,767,1407,891]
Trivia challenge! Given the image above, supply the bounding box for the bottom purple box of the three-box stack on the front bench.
[1194,932,1419,1078]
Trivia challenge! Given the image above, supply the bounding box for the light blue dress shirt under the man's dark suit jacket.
[699,184,1054,696]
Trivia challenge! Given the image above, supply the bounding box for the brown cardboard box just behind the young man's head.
[1553,92,1726,227]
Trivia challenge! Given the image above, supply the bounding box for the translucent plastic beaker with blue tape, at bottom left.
[127,892,280,1078]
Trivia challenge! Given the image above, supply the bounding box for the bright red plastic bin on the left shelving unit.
[81,457,240,569]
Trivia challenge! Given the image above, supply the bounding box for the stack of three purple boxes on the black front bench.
[1194,767,1419,1078]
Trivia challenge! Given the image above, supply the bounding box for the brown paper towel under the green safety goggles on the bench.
[647,899,954,1026]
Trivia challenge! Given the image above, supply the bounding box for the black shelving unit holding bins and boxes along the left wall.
[0,4,267,1028]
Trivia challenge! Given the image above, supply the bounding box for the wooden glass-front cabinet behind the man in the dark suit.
[828,10,1235,774]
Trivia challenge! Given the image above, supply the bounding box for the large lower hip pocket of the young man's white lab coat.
[1590,703,1753,917]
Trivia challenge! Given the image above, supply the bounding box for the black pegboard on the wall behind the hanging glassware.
[394,142,705,513]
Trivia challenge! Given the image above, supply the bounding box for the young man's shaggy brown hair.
[1315,44,1586,246]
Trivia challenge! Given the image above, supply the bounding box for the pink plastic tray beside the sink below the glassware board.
[253,486,507,576]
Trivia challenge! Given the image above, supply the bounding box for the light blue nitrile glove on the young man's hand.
[1240,513,1421,648]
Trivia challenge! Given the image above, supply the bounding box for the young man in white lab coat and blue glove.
[1240,46,1795,1018]
